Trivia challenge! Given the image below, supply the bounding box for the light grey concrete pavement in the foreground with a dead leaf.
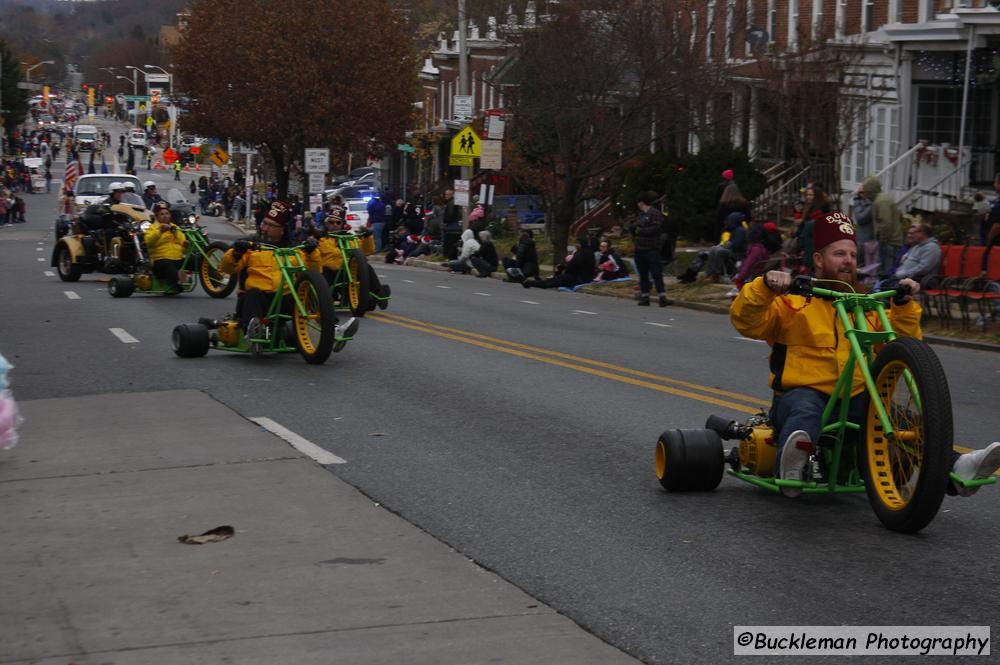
[0,387,637,665]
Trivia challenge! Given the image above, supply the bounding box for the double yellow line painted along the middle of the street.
[369,312,771,413]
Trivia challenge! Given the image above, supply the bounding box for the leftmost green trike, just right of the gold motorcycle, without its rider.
[108,223,236,298]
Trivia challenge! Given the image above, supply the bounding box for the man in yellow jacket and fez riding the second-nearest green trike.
[219,201,357,338]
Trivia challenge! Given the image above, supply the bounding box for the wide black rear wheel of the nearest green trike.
[655,429,725,492]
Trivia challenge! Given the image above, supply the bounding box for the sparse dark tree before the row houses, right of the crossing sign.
[510,0,720,254]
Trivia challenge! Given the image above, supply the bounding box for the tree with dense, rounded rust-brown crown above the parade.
[171,0,417,196]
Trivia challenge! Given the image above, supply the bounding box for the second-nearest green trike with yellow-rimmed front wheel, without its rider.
[173,243,353,365]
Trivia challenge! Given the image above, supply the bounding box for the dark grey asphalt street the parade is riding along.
[0,116,1000,663]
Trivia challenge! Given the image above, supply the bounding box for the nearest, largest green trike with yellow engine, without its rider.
[656,277,996,532]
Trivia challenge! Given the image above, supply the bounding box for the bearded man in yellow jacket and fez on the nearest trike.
[729,213,1000,496]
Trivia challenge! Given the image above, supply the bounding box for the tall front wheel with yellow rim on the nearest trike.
[861,337,952,533]
